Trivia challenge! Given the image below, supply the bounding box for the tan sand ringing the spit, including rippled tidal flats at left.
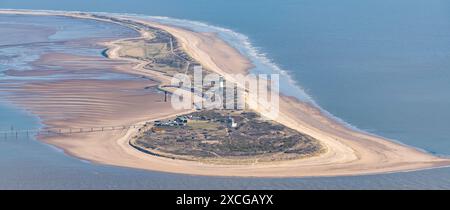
[0,10,450,177]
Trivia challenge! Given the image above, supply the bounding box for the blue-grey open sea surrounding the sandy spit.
[0,0,450,189]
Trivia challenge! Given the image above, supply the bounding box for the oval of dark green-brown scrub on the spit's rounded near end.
[133,110,324,160]
